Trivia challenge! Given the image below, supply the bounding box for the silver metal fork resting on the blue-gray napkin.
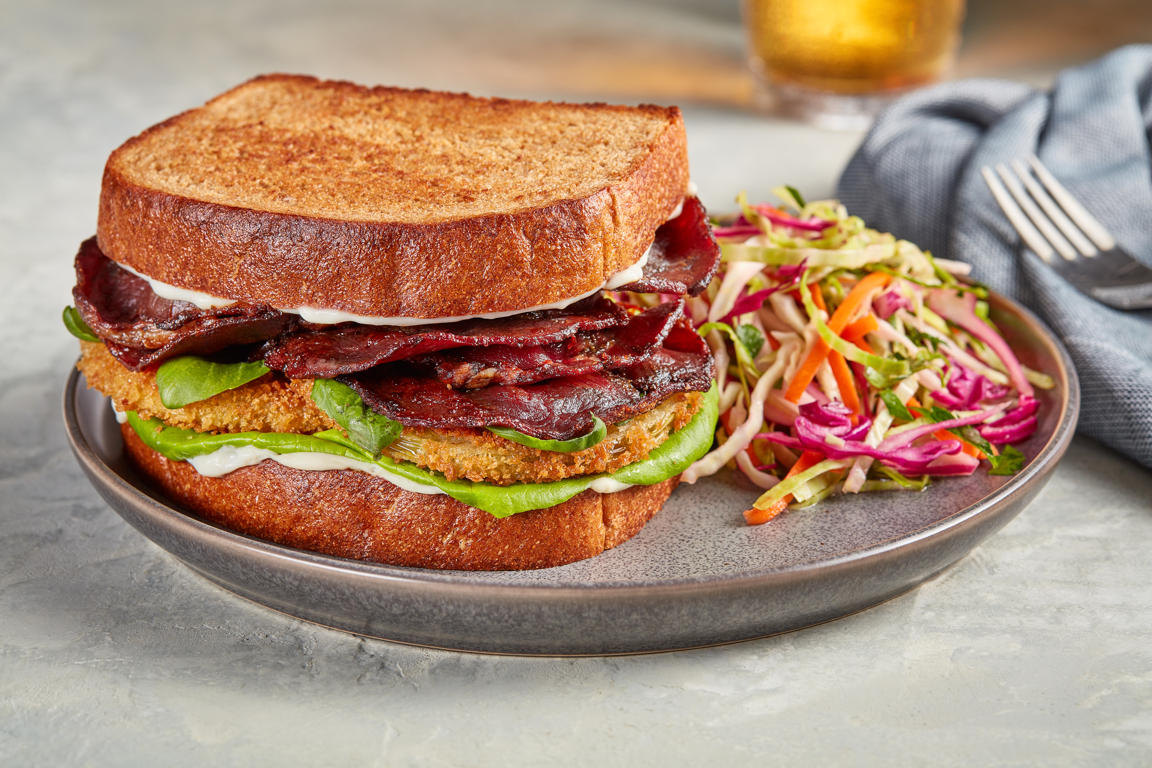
[980,154,1152,310]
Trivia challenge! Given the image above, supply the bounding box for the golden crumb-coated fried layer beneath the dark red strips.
[76,341,704,485]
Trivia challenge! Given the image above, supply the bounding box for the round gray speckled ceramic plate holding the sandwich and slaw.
[65,292,1079,655]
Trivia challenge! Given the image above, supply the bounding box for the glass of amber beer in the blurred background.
[744,0,964,128]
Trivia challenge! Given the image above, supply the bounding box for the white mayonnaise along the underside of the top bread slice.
[116,193,696,326]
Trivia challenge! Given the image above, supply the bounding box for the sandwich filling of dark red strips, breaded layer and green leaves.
[74,198,719,515]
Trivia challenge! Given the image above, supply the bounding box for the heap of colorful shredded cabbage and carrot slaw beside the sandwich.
[622,188,1054,525]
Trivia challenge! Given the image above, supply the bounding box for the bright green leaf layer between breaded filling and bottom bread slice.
[128,383,720,517]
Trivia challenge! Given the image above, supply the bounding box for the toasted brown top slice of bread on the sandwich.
[97,75,688,319]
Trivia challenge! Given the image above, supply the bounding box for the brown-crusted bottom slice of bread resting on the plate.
[121,424,680,570]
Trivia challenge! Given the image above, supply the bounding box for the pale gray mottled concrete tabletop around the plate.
[0,0,1152,766]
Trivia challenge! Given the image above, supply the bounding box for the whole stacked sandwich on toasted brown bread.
[65,75,719,570]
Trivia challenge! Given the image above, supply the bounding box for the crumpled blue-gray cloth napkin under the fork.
[839,45,1152,466]
